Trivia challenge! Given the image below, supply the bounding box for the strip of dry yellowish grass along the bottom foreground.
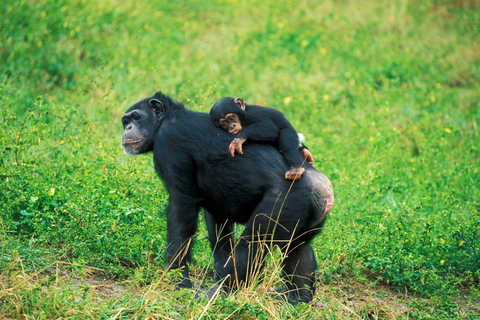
[0,259,480,319]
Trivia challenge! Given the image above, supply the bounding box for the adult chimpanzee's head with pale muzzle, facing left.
[122,92,171,155]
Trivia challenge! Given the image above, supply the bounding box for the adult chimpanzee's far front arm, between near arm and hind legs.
[203,209,234,281]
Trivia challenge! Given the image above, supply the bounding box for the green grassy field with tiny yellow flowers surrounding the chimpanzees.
[0,0,480,319]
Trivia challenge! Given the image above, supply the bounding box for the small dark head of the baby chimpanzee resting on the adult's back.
[210,97,245,135]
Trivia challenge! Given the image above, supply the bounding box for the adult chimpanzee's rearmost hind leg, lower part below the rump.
[283,242,317,304]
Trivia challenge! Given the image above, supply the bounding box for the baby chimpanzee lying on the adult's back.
[210,97,313,180]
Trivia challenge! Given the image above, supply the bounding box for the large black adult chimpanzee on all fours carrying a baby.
[122,92,333,303]
